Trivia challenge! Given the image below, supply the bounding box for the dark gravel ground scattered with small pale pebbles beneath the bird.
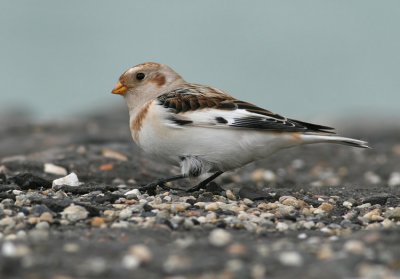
[0,111,400,279]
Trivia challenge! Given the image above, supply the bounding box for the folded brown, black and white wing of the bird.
[158,84,334,133]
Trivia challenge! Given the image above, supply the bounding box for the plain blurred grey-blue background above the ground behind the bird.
[0,0,400,122]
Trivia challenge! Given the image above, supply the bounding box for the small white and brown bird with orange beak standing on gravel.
[112,62,368,190]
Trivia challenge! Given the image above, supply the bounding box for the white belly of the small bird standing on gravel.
[136,117,295,171]
